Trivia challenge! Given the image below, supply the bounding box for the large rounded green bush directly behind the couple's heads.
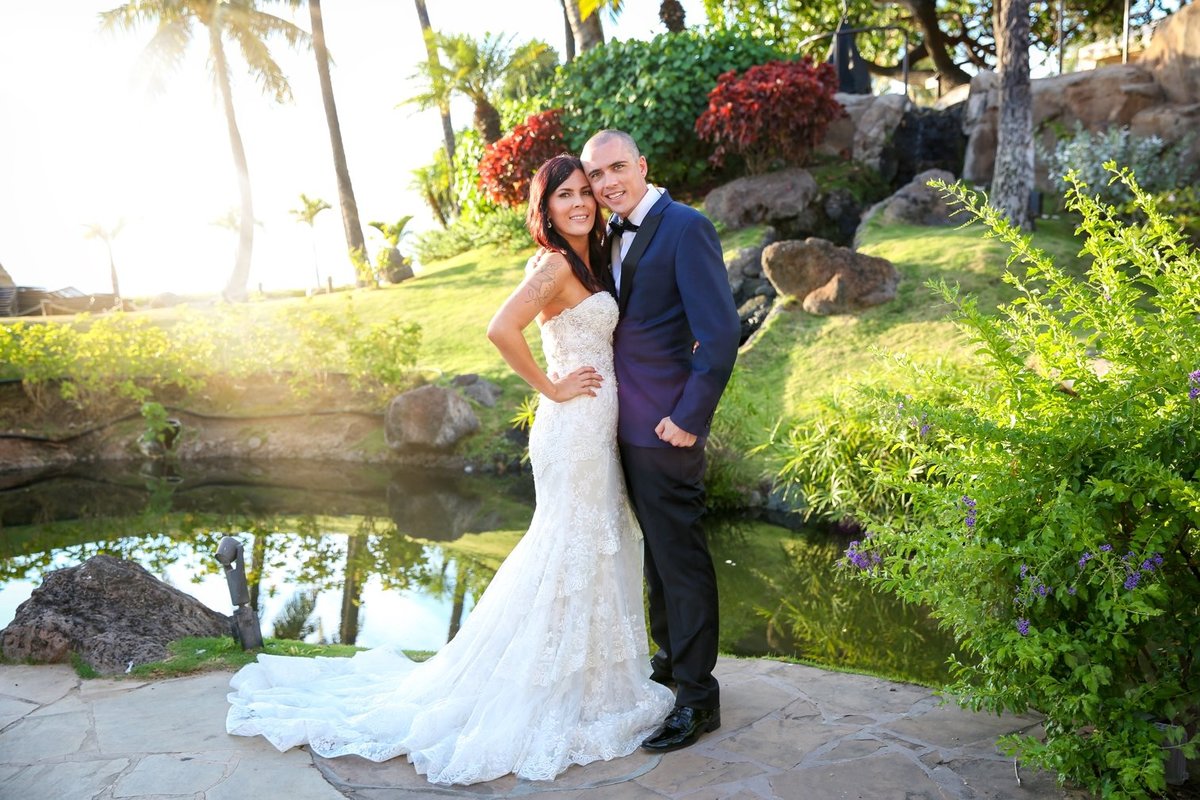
[550,31,786,188]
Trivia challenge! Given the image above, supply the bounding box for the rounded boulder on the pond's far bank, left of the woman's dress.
[384,385,479,451]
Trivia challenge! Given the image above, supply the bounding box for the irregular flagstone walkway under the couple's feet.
[0,658,1085,800]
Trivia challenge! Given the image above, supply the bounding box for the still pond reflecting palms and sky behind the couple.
[0,462,953,682]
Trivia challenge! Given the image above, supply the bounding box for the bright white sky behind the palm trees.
[0,0,704,297]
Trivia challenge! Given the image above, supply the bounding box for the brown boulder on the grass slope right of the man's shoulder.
[762,239,900,317]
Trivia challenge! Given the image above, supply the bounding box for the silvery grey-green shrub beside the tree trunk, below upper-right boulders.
[1040,122,1195,205]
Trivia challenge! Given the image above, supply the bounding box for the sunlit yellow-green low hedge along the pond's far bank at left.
[0,295,421,412]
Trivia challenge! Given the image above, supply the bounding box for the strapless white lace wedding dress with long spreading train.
[226,293,674,783]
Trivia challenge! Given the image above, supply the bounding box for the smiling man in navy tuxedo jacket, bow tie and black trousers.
[580,131,740,752]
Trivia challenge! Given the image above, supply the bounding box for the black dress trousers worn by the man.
[620,440,720,709]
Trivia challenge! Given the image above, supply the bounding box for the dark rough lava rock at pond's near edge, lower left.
[0,555,230,674]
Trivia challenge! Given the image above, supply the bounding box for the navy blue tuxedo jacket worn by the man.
[613,191,740,447]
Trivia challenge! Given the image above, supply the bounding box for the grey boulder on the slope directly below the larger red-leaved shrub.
[704,168,820,230]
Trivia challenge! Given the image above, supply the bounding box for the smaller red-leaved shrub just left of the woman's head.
[479,108,566,207]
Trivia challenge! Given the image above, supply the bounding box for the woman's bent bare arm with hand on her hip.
[487,253,601,403]
